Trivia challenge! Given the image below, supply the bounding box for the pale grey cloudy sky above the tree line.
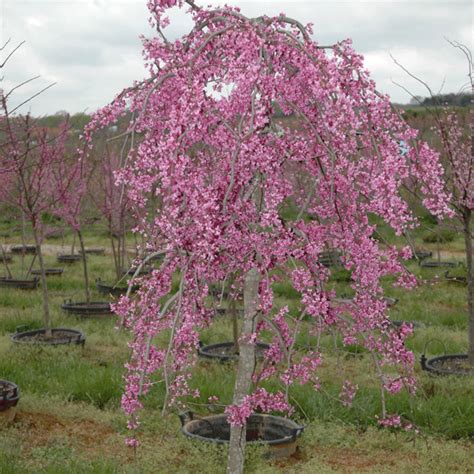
[0,0,473,114]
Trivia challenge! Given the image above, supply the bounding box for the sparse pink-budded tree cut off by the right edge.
[395,41,474,367]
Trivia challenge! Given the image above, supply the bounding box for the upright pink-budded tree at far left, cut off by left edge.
[0,85,69,337]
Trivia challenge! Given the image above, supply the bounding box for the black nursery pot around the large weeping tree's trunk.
[179,412,304,459]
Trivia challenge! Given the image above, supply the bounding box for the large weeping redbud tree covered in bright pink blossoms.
[86,0,447,472]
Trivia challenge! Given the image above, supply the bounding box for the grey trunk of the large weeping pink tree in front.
[227,268,260,474]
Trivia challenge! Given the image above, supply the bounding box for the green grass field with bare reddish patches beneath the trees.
[0,220,474,473]
